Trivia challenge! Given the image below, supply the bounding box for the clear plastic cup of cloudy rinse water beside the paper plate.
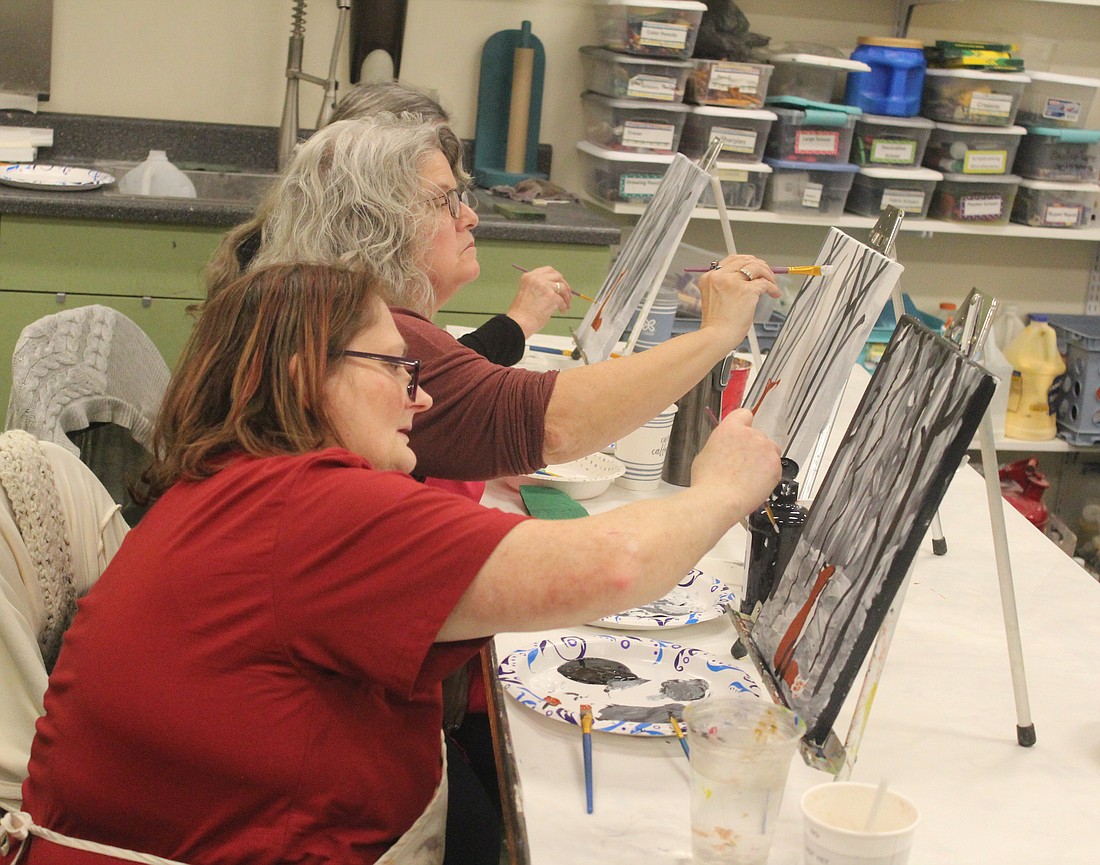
[684,694,806,865]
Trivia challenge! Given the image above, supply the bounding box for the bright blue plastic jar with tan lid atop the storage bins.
[844,36,925,117]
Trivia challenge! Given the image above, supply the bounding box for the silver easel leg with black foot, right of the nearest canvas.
[978,408,1035,747]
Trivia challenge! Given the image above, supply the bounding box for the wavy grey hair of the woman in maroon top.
[250,112,465,316]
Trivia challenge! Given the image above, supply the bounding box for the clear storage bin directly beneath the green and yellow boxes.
[921,69,1031,127]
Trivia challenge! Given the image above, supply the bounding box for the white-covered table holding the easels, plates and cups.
[483,451,1100,865]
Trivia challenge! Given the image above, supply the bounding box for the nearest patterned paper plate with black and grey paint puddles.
[497,634,761,736]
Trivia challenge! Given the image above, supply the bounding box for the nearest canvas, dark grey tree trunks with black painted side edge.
[750,317,994,743]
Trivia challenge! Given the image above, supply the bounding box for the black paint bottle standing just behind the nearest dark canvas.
[741,457,809,615]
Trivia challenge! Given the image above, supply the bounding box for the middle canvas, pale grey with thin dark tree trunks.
[743,228,904,477]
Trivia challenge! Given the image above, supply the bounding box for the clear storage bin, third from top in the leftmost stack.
[581,94,689,153]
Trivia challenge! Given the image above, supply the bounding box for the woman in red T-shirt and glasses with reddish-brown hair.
[9,264,780,865]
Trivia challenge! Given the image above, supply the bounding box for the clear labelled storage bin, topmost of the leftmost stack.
[593,0,706,59]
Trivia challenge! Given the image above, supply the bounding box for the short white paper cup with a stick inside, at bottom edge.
[802,781,920,865]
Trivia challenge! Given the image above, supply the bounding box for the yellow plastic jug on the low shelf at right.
[1004,314,1066,441]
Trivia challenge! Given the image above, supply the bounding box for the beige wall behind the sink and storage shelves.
[32,0,1100,313]
